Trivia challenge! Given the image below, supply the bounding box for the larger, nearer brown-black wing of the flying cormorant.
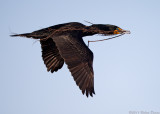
[52,35,95,97]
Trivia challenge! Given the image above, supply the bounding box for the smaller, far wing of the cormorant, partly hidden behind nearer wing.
[40,38,64,73]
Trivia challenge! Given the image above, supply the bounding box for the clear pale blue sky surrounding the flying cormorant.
[0,0,160,114]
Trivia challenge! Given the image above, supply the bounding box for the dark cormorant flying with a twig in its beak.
[11,22,130,97]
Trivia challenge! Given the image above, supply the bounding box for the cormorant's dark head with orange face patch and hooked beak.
[91,24,130,35]
